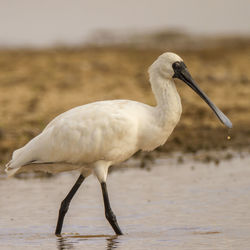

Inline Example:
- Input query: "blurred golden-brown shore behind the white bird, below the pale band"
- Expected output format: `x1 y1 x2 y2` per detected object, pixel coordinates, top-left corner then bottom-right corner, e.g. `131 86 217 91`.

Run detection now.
0 37 250 166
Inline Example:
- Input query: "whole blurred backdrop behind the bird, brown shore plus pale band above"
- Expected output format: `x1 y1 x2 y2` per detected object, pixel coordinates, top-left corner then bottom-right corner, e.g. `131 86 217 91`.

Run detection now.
0 0 250 166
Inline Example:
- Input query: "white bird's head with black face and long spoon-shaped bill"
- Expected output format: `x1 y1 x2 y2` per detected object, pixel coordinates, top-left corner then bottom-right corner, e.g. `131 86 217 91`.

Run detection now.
149 52 232 128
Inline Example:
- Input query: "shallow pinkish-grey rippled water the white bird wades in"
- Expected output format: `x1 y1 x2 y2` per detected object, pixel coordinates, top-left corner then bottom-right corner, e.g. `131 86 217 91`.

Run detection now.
0 153 250 250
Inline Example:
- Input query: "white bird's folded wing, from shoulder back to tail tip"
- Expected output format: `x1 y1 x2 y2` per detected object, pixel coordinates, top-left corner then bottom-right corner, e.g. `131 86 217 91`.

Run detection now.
6 101 142 174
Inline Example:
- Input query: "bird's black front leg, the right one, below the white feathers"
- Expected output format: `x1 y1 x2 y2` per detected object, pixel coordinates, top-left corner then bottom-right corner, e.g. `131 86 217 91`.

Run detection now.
101 182 122 235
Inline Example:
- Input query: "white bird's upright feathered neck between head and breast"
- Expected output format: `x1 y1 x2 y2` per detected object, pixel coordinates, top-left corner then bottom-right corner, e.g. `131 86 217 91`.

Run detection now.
150 74 182 126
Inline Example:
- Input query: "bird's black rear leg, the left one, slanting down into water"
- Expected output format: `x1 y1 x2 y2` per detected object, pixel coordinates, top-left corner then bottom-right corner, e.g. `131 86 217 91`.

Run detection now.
55 175 85 235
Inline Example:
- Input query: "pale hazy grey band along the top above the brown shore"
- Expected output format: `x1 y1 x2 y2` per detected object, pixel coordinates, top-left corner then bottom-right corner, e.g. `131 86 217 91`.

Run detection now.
0 0 250 46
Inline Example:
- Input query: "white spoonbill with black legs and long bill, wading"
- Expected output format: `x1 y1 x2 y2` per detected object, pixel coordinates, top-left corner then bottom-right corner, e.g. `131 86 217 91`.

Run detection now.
5 52 232 236
